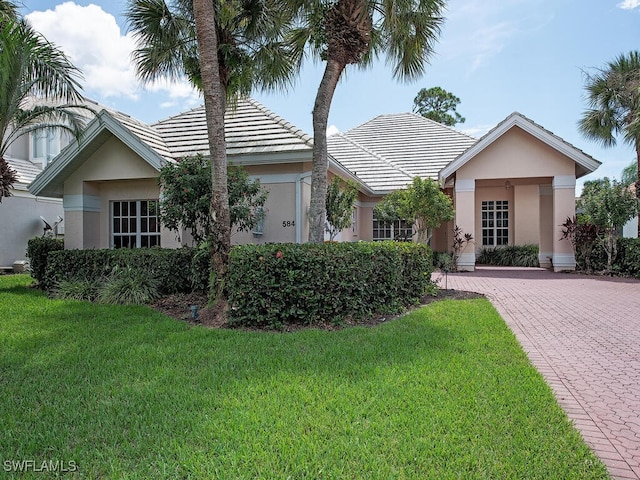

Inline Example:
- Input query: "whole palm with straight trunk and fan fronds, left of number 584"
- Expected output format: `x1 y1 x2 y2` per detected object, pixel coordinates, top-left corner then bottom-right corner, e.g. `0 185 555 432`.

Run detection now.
126 0 300 313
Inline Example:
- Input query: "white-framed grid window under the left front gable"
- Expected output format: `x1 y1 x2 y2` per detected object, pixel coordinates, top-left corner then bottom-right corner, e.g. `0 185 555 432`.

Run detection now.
111 200 160 248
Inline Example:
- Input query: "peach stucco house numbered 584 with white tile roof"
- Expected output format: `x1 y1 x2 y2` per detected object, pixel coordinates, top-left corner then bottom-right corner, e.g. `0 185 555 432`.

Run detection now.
29 99 600 270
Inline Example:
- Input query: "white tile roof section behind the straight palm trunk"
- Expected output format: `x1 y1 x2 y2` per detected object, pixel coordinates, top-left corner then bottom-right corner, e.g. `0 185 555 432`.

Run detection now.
152 98 313 159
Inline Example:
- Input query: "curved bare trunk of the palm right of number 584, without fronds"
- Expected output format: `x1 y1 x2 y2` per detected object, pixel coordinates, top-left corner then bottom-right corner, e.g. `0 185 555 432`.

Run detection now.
309 58 345 243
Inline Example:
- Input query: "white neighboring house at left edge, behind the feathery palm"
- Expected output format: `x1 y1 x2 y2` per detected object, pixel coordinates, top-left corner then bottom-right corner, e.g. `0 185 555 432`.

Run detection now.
0 128 66 270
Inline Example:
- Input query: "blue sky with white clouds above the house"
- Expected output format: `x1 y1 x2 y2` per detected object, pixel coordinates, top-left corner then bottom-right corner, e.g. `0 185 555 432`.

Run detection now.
22 0 640 190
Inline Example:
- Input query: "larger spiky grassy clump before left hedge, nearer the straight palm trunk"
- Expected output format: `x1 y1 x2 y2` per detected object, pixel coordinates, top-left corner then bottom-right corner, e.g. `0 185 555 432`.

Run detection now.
98 267 160 305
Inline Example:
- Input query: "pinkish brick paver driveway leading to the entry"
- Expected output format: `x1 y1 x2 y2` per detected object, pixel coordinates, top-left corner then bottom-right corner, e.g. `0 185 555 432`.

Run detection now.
434 267 640 479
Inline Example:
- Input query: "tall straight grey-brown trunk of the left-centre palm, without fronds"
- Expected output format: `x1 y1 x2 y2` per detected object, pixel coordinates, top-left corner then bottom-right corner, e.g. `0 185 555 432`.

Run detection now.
193 0 231 315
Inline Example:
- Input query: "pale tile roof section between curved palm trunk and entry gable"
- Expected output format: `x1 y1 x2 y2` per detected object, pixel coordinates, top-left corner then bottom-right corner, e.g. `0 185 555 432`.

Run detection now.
328 113 476 190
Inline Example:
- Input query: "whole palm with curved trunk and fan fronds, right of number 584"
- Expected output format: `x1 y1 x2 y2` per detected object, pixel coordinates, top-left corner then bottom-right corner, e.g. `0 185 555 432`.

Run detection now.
292 0 445 243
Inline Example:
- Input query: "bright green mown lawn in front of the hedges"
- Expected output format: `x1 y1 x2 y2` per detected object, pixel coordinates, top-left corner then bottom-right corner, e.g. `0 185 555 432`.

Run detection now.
0 276 608 479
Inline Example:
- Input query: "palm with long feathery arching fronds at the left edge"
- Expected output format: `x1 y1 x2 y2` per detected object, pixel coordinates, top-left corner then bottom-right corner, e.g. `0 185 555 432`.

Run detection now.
0 10 86 201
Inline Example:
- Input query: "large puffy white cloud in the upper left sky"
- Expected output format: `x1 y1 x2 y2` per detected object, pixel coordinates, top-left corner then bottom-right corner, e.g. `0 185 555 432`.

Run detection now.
27 1 200 106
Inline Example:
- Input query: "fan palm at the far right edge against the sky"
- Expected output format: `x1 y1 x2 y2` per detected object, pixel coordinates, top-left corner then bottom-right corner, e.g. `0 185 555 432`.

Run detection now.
578 51 640 237
